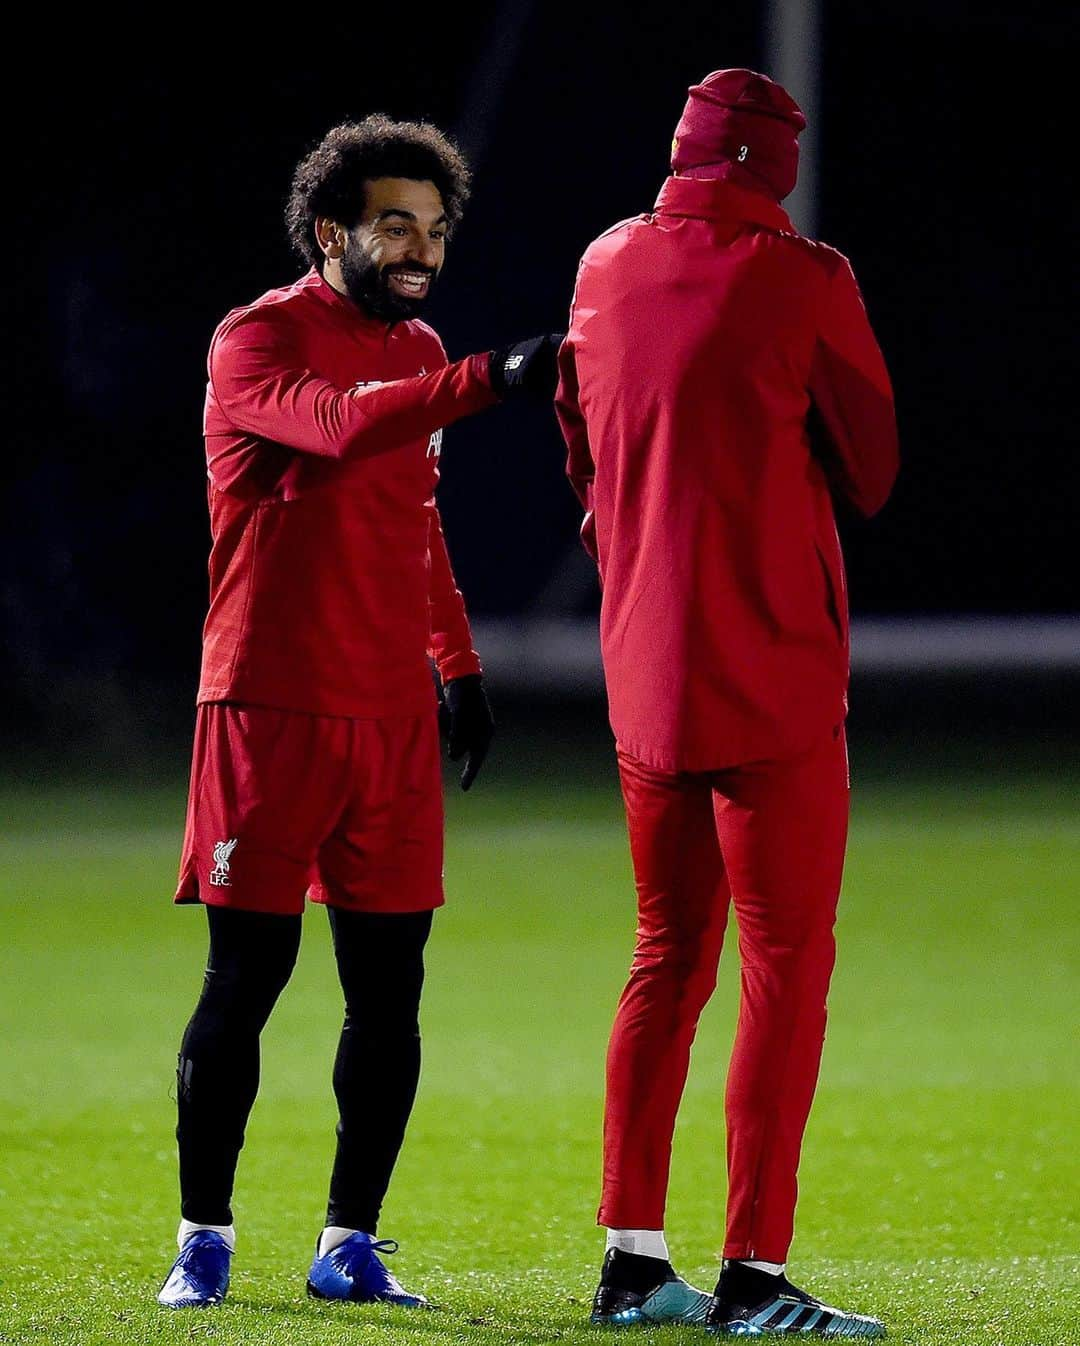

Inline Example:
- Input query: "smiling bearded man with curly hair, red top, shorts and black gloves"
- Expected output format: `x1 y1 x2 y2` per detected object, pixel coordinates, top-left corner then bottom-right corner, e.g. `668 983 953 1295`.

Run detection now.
158 116 558 1308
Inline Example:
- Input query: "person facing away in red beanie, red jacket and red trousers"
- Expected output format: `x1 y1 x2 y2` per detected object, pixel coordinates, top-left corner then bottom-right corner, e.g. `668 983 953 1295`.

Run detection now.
556 70 897 1337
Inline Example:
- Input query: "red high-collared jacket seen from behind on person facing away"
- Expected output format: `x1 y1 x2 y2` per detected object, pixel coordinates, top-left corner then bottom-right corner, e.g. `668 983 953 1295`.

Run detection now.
558 178 897 771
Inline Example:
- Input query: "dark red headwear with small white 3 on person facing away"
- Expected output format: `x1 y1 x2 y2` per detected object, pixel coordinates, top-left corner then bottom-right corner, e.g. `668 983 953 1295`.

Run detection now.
671 70 807 201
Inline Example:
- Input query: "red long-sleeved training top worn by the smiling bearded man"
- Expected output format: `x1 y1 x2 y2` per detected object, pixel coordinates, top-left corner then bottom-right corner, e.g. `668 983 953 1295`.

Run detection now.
198 269 497 717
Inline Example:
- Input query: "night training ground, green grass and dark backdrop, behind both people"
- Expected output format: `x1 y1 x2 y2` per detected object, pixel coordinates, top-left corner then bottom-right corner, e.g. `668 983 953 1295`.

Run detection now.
0 0 1080 1346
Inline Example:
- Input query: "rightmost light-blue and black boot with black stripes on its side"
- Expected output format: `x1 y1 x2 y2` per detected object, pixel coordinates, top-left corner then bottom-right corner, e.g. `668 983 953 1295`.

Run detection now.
706 1263 885 1341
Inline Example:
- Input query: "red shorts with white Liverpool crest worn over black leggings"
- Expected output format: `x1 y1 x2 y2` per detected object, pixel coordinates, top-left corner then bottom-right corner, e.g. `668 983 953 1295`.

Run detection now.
175 703 443 915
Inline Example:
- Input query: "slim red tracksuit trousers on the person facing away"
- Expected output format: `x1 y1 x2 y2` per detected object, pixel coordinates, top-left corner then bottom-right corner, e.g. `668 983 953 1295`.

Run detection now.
598 730 848 1263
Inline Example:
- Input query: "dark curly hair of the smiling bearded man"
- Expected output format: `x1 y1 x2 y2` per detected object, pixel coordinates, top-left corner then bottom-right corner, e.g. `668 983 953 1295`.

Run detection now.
285 112 470 271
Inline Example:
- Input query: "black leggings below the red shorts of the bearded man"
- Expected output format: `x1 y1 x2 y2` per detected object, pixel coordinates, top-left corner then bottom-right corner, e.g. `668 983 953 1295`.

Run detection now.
176 906 431 1233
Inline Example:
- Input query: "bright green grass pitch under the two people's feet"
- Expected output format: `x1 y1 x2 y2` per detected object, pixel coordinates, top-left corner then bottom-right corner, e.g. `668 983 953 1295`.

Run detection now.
0 763 1080 1346
